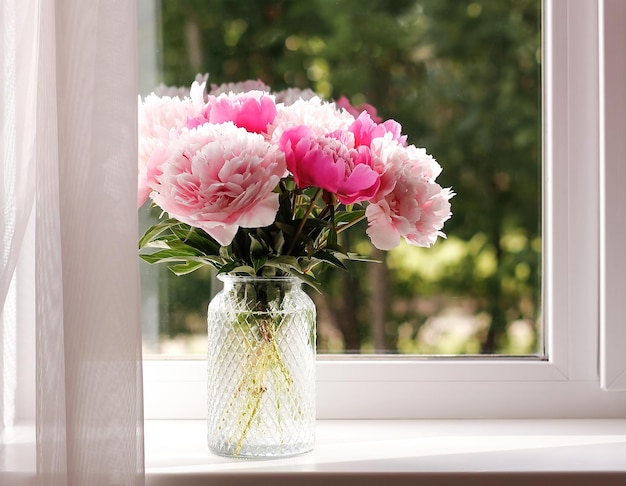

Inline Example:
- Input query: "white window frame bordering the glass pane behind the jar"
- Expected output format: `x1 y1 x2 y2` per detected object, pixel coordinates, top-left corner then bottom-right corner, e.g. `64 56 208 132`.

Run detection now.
144 0 626 419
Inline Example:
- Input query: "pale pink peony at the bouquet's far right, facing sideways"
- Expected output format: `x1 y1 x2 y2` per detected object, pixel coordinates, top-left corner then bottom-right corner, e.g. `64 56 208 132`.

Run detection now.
365 137 454 250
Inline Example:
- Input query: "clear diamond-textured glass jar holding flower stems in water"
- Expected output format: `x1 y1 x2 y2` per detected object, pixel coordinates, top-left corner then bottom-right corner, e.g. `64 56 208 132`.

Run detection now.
208 275 316 458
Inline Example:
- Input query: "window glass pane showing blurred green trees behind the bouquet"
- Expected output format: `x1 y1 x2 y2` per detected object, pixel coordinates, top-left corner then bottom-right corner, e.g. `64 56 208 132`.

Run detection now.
138 0 543 355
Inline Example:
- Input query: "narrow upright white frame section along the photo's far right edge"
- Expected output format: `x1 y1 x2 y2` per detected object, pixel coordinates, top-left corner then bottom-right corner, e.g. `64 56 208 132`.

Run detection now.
600 0 626 390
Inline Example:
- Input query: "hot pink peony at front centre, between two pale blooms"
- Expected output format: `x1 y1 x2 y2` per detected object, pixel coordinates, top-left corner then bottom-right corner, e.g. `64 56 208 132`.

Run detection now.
279 126 380 204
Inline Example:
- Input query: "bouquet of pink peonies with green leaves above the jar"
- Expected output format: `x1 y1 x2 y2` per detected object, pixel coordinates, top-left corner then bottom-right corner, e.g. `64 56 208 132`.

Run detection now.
138 76 454 289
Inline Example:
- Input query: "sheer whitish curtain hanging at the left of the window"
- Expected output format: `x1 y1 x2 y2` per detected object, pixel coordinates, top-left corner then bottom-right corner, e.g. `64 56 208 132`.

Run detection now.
0 0 144 486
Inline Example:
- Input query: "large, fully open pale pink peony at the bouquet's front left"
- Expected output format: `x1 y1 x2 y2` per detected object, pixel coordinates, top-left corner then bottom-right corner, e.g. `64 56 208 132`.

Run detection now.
148 123 285 246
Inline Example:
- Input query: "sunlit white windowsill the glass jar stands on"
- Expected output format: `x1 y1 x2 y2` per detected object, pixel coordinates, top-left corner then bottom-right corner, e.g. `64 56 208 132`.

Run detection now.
145 419 626 486
